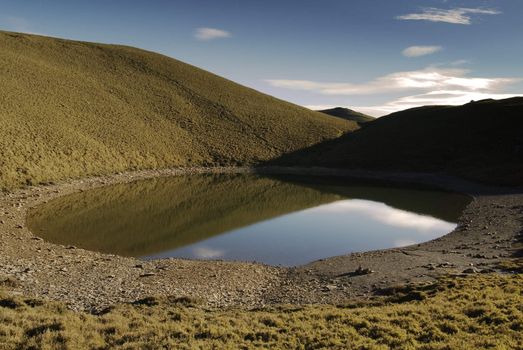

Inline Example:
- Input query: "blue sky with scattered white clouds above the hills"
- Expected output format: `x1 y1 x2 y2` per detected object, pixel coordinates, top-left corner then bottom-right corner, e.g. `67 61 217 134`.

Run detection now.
0 0 523 116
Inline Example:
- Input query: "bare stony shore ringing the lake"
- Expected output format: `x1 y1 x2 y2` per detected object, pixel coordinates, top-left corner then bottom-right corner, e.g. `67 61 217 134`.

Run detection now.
0 168 523 311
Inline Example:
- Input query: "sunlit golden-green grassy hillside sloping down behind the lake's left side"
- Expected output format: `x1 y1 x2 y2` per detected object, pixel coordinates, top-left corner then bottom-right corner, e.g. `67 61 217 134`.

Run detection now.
0 32 356 188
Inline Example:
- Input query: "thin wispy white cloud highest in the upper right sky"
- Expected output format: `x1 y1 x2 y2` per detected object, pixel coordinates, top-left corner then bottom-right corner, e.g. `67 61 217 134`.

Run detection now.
396 7 501 25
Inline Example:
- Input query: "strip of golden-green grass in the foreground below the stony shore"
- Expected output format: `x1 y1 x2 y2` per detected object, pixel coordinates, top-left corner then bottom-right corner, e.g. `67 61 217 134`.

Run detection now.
0 274 523 349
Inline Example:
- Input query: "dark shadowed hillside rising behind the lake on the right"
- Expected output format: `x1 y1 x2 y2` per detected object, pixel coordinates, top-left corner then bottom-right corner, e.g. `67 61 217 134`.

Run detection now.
277 97 523 185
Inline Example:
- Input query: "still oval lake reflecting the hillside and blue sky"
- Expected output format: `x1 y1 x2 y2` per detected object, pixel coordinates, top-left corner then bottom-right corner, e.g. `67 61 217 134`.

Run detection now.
27 174 469 266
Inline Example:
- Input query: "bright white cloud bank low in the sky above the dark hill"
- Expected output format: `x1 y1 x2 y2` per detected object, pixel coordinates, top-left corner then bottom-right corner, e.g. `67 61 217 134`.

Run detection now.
292 67 523 117
